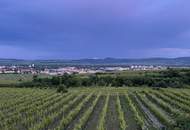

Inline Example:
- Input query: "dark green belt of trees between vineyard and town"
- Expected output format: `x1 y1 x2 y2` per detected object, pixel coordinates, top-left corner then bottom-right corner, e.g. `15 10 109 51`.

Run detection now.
19 68 190 88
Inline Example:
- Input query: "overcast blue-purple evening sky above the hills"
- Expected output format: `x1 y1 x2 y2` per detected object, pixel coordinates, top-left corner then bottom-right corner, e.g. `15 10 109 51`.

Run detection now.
0 0 190 59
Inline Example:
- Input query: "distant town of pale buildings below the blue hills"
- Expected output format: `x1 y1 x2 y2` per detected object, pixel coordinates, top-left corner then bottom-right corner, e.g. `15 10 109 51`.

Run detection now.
0 64 167 75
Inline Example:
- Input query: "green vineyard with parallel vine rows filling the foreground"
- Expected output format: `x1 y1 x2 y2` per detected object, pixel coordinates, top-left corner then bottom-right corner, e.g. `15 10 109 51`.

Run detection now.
0 87 190 130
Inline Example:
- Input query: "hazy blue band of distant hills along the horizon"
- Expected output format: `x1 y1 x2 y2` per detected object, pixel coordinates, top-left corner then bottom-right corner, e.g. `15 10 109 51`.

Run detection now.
0 57 190 66
